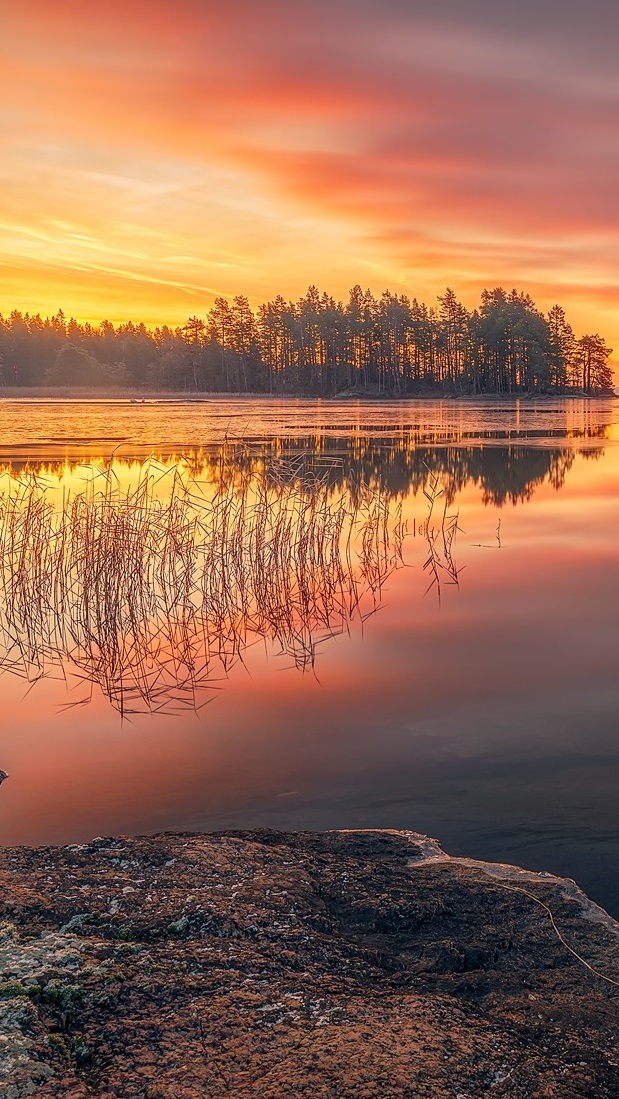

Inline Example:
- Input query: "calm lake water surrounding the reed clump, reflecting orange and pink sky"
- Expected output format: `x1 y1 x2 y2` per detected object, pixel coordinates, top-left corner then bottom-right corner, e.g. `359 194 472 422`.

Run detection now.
0 400 619 914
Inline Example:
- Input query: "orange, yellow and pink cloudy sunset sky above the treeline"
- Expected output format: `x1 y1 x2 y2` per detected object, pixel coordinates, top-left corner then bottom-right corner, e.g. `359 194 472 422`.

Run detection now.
0 0 619 362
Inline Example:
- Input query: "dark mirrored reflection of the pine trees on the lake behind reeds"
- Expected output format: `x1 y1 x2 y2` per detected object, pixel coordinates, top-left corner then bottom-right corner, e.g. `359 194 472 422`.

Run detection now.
0 423 610 507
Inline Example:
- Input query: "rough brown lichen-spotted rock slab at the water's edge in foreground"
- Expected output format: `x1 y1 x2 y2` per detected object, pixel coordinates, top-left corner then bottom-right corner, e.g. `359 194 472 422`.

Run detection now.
0 832 619 1099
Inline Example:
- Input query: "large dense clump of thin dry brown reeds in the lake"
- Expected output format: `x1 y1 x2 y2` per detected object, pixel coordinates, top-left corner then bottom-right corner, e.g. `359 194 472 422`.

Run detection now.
0 456 405 717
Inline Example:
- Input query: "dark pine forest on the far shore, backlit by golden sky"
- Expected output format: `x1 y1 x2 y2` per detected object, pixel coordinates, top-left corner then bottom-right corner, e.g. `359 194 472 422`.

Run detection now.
0 286 612 397
